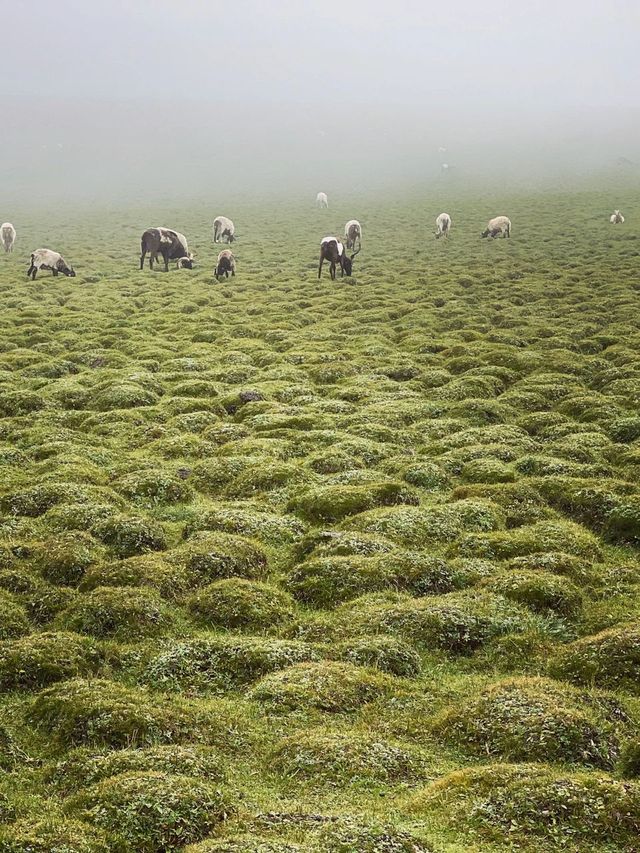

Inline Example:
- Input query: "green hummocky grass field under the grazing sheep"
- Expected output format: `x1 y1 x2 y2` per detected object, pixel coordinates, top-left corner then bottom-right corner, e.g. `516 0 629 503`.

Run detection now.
0 190 640 853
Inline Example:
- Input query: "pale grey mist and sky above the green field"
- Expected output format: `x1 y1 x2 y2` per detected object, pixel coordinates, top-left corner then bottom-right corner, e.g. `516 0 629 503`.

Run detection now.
0 0 640 203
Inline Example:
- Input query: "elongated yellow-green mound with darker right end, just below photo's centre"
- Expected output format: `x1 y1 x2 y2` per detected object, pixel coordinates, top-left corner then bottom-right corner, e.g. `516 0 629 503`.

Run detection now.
289 482 419 524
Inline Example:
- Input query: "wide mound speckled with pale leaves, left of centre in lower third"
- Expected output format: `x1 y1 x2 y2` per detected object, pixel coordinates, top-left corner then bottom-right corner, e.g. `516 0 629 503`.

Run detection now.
142 635 320 693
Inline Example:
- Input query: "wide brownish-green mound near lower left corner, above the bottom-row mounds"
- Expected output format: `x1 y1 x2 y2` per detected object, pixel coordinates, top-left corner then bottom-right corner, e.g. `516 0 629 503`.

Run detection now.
27 678 207 749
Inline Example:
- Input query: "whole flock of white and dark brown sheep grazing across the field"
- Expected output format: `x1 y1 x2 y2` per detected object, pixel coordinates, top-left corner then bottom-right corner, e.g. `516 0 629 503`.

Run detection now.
0 198 624 281
